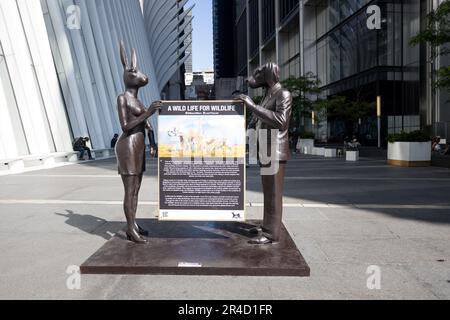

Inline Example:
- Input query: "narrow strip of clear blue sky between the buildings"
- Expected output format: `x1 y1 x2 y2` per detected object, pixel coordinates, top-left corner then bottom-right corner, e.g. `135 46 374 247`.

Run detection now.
188 0 214 71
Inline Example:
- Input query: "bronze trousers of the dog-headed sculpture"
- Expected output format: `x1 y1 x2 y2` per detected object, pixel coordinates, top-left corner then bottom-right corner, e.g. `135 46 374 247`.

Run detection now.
262 162 286 241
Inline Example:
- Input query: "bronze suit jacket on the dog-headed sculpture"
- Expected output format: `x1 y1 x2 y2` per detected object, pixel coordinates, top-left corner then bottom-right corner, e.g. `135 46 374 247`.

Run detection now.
248 84 292 161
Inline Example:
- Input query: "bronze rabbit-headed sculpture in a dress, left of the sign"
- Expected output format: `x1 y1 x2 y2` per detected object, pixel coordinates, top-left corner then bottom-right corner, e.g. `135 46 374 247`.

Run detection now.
115 42 161 244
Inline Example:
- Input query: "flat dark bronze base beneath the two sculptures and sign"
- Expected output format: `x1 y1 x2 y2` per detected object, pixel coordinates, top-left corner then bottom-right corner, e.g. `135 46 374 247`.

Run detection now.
81 220 310 277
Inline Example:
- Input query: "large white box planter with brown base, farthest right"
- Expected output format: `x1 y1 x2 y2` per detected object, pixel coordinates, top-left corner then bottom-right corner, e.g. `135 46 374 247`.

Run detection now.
388 142 431 167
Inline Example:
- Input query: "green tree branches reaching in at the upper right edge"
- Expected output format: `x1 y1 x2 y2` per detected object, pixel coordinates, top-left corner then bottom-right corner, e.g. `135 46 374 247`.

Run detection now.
410 0 450 90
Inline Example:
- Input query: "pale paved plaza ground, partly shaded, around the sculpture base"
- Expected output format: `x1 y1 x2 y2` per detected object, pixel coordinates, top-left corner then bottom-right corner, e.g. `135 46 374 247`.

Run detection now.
0 156 450 300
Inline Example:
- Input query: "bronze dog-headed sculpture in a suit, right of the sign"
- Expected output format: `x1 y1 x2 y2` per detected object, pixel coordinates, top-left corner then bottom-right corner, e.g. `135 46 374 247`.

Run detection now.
236 63 292 244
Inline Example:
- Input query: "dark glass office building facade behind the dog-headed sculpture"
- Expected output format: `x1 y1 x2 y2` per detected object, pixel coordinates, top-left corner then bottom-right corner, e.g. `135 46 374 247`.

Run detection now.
225 0 450 145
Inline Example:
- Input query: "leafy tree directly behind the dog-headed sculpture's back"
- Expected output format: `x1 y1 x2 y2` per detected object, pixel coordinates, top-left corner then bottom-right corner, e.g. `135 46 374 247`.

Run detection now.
282 72 321 127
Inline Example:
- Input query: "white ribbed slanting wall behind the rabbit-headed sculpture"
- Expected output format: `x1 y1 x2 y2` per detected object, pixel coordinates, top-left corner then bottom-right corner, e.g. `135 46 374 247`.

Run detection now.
0 0 162 162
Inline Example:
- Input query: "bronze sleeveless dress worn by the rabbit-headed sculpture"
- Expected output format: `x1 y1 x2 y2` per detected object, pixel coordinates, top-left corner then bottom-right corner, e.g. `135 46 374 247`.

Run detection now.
116 98 146 176
